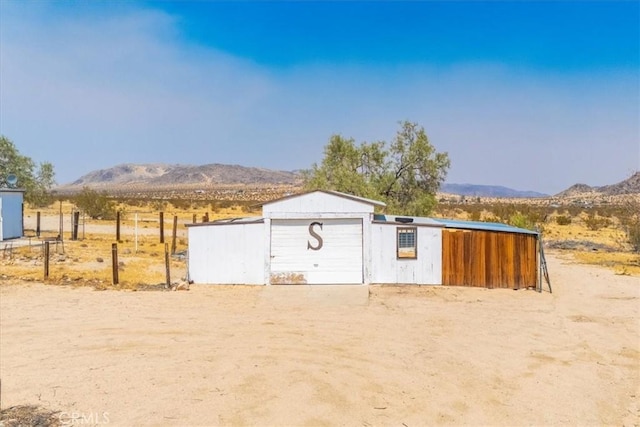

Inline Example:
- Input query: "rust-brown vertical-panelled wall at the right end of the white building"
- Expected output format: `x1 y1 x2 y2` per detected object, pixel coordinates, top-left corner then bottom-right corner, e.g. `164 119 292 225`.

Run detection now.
442 230 538 289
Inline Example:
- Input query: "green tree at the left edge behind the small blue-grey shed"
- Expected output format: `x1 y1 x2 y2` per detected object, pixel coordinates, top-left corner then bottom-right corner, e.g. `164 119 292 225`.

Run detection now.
0 136 55 206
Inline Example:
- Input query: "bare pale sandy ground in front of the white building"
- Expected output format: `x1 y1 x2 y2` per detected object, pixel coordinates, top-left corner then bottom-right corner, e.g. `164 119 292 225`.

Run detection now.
0 254 640 426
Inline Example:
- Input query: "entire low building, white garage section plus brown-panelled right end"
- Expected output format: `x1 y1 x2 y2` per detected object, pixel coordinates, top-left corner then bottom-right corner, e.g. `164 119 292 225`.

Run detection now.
187 190 538 289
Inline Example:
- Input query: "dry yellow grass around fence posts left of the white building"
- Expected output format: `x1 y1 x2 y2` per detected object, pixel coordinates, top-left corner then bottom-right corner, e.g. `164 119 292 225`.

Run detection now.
0 202 258 290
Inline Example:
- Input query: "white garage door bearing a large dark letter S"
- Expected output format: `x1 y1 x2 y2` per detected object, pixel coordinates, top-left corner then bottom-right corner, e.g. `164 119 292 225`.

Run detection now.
270 218 363 284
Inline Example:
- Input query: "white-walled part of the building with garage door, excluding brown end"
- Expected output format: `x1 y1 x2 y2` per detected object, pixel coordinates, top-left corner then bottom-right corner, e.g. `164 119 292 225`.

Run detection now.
187 190 443 285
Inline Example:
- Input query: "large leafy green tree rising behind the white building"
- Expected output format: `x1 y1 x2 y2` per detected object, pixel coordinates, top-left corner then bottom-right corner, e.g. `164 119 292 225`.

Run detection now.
303 121 451 215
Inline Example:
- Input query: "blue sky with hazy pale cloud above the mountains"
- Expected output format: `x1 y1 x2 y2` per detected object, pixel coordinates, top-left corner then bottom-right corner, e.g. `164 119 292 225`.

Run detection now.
0 0 640 194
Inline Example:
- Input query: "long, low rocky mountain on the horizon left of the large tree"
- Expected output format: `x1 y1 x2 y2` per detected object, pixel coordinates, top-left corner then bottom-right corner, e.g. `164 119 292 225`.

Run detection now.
58 163 300 190
